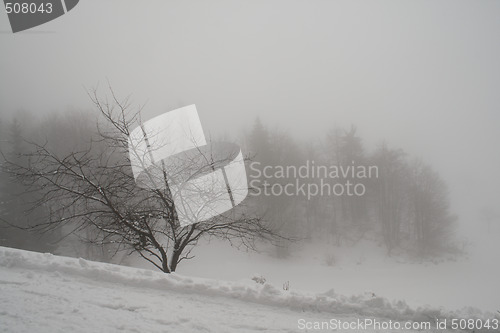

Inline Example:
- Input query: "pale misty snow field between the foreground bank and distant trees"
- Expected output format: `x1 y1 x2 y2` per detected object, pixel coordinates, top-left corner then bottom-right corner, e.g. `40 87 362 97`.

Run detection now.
171 232 500 312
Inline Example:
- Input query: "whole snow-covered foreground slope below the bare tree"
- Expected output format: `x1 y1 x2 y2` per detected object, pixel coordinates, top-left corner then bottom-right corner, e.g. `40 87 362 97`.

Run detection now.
0 248 498 332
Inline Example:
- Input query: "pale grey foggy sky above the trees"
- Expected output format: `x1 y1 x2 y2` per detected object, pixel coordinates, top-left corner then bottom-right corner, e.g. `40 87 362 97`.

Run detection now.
0 0 500 233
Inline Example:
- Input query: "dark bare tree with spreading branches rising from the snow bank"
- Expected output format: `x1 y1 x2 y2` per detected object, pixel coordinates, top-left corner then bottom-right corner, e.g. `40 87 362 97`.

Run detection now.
0 88 281 273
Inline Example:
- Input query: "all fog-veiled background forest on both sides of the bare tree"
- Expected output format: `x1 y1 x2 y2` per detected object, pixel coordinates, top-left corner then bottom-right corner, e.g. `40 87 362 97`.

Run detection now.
0 100 464 268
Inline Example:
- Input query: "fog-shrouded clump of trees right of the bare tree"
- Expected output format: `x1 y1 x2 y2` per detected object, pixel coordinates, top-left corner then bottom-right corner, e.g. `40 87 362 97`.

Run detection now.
243 119 456 257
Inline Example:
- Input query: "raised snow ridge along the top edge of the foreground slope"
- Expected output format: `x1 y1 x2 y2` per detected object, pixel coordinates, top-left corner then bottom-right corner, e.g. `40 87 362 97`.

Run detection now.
0 247 492 322
